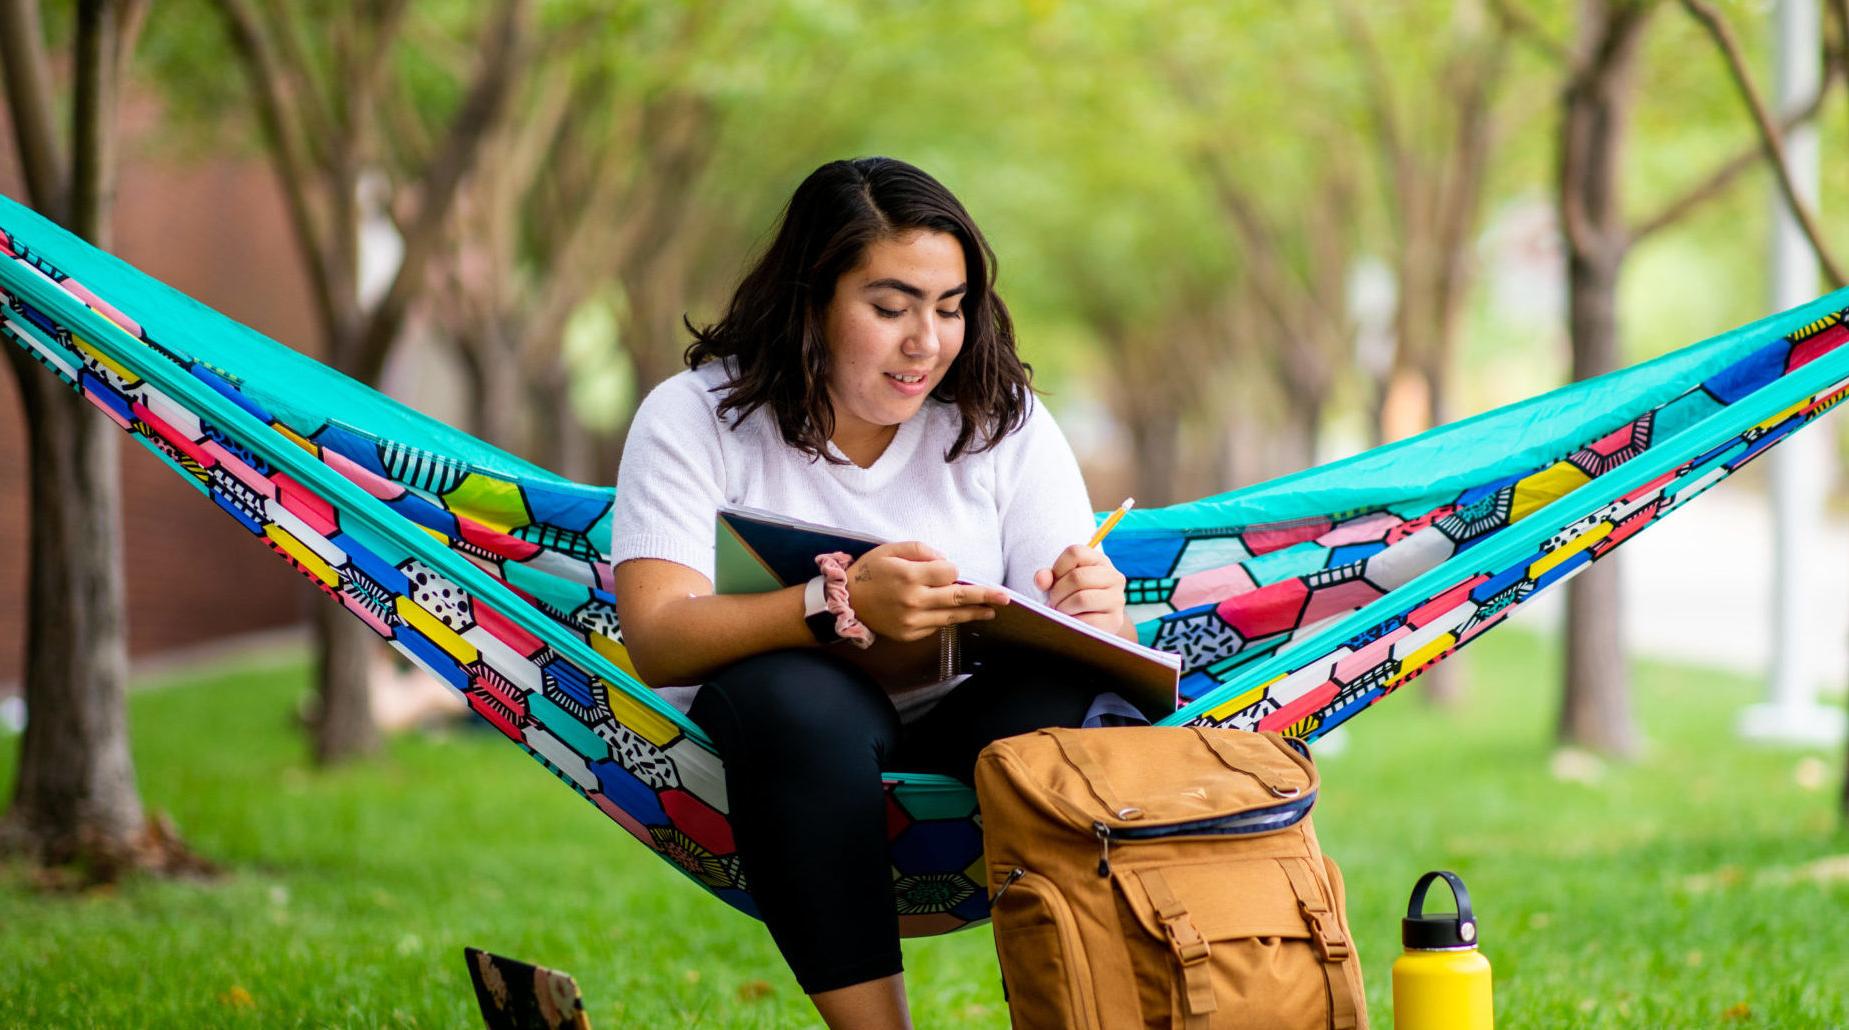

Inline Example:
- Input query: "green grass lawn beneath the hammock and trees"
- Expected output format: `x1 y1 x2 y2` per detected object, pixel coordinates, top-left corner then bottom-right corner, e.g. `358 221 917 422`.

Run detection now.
0 631 1849 1028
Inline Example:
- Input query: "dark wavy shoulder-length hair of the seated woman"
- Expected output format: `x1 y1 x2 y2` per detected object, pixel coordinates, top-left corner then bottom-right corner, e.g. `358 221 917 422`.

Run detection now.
682 157 1034 464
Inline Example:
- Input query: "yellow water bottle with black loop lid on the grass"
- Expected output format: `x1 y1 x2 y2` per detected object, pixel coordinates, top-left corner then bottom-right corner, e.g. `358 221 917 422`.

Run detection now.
1392 873 1496 1030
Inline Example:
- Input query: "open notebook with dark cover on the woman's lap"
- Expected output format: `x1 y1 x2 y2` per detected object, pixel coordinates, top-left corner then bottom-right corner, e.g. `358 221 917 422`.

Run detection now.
714 507 1182 719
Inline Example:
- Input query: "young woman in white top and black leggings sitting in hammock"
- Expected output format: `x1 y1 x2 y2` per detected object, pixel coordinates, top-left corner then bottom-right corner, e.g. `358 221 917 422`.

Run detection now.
612 157 1135 1026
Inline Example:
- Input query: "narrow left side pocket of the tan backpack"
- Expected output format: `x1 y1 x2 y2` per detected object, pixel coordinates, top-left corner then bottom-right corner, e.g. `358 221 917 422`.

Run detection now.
989 867 1098 1030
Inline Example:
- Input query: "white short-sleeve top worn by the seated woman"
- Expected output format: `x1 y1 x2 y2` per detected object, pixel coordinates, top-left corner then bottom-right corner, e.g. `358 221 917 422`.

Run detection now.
610 361 1096 719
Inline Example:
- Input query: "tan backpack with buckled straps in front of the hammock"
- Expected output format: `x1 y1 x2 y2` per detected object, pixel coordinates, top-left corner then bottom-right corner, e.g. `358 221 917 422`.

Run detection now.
976 727 1366 1030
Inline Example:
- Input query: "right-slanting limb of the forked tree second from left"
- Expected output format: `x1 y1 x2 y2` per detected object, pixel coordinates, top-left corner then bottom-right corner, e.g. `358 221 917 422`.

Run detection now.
348 0 531 383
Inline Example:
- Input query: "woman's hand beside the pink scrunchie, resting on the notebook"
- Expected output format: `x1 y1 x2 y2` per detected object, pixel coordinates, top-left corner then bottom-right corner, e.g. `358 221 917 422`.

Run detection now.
847 540 1008 642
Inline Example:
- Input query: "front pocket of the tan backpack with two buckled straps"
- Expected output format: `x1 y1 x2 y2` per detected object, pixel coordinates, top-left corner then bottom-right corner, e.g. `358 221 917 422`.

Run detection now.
1111 856 1359 1030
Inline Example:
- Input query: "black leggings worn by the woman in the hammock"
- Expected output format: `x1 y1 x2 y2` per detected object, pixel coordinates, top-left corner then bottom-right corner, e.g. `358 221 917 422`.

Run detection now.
690 649 1108 995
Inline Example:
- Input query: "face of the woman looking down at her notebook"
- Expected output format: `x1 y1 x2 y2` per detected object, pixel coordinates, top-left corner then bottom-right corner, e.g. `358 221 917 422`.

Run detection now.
823 229 969 440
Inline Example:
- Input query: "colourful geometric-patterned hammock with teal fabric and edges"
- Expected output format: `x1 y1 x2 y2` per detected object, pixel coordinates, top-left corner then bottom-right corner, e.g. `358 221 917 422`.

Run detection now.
0 190 1849 936
